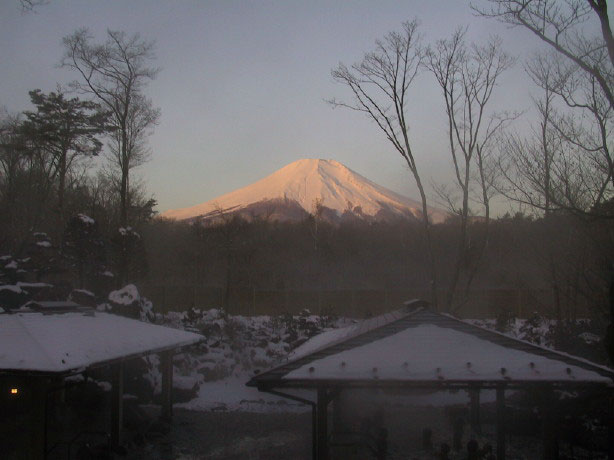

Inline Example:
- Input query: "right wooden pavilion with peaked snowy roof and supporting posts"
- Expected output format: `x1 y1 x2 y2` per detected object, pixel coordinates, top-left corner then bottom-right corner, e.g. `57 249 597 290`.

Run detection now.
247 301 614 460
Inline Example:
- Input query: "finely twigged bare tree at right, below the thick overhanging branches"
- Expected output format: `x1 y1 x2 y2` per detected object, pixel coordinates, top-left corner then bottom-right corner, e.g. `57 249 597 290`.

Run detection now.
500 49 614 217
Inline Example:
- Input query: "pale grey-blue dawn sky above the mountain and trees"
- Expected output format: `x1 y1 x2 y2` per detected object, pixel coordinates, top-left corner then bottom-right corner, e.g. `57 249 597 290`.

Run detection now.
0 0 592 216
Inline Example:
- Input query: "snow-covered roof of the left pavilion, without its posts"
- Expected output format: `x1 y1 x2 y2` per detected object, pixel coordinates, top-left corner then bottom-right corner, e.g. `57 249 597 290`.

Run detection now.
0 310 202 374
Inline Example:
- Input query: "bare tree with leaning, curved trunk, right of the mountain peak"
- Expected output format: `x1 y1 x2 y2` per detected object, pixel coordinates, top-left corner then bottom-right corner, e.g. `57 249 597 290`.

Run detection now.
328 20 437 305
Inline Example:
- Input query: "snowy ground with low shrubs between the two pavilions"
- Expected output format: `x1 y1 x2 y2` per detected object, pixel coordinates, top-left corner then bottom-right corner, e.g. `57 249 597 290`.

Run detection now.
158 309 348 412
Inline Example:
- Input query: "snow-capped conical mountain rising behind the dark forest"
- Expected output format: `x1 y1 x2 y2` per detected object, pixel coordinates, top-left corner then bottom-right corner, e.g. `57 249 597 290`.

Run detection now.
162 159 448 223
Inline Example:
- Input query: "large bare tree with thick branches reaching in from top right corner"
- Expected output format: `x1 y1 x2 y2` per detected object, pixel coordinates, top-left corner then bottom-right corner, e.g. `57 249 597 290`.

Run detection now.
472 0 614 362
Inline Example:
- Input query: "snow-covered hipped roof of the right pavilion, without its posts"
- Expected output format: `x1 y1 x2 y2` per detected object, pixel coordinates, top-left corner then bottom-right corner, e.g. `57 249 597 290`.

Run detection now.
248 303 614 389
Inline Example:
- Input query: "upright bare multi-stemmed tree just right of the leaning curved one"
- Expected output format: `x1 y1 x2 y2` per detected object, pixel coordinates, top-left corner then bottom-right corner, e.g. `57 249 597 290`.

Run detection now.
425 29 514 309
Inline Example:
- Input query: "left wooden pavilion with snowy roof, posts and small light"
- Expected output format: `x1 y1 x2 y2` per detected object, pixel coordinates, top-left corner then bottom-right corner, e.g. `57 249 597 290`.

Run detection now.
0 302 202 459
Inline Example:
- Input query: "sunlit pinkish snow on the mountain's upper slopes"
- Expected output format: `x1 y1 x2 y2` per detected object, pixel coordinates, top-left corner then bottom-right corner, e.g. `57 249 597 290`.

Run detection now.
162 159 448 223
